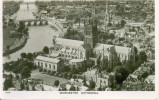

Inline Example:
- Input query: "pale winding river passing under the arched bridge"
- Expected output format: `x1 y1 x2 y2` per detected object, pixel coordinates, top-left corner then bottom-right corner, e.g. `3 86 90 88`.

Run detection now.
3 3 59 63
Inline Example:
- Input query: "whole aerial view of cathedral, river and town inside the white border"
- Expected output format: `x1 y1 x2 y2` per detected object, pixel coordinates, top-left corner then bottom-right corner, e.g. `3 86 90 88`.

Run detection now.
2 0 155 91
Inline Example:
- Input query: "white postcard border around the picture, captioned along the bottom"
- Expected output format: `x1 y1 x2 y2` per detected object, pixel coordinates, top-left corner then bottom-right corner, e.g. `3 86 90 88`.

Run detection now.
0 0 159 100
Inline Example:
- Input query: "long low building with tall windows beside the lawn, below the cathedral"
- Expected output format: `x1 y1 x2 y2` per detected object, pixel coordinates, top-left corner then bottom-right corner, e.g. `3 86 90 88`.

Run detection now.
34 56 64 72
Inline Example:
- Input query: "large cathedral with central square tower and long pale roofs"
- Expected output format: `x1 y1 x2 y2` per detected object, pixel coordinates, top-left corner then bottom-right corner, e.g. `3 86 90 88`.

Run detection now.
50 17 134 67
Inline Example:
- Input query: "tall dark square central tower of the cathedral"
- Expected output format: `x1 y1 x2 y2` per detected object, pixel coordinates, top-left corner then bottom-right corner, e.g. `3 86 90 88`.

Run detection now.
84 18 97 49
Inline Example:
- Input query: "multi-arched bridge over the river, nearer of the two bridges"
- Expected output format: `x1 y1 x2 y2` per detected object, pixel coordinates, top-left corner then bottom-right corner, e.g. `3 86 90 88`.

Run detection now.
17 19 48 26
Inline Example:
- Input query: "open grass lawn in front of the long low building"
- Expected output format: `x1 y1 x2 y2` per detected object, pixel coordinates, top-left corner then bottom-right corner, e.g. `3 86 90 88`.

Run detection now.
30 70 69 86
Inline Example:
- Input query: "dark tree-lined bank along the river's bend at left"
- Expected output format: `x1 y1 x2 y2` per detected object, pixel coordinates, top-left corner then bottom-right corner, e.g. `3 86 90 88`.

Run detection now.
3 35 27 56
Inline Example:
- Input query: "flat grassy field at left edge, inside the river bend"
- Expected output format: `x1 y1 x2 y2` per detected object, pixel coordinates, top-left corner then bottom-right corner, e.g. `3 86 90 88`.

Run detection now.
3 26 16 50
